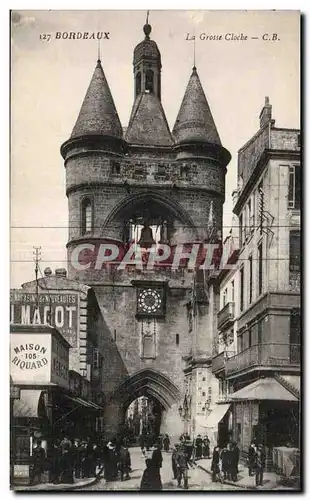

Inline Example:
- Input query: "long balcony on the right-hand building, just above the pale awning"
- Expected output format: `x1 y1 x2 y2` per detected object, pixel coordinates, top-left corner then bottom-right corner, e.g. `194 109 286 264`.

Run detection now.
225 343 300 375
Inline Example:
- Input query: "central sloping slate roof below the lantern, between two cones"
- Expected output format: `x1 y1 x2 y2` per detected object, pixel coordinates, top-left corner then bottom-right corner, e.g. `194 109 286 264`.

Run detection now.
125 92 173 146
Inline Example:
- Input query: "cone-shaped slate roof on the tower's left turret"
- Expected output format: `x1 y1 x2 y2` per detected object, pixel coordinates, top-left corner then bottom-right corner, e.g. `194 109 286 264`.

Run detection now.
71 60 123 139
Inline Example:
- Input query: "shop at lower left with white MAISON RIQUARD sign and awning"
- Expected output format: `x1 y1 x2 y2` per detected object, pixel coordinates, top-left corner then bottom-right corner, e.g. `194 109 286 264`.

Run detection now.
10 325 102 484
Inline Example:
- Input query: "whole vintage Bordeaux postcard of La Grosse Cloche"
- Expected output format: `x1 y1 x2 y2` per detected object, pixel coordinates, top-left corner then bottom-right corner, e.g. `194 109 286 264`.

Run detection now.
9 10 302 492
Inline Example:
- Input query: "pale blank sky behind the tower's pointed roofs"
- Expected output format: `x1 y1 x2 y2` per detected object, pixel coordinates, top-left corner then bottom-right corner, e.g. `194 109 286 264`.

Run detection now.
11 11 300 287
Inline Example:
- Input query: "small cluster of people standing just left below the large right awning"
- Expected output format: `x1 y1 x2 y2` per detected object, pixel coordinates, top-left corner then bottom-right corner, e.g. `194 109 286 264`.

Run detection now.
211 442 240 482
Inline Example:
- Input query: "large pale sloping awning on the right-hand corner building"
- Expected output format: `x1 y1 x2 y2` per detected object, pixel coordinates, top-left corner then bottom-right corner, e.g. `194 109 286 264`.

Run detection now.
229 378 298 401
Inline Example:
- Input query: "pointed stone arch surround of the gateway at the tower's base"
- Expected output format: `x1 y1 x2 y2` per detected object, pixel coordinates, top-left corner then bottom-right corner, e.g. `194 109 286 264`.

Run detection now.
105 368 184 440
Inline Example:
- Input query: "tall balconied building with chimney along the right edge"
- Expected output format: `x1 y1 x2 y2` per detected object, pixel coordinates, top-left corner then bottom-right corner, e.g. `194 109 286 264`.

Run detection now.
213 98 301 459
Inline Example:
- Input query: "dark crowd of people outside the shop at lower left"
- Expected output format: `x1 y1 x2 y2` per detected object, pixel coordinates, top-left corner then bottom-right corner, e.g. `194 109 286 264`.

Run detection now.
30 436 102 485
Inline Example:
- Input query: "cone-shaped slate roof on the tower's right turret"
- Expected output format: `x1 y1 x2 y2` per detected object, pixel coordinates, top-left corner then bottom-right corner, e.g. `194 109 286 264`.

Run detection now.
172 67 221 145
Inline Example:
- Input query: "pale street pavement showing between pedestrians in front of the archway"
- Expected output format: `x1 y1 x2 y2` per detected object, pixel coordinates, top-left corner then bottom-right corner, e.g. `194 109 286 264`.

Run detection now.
83 448 241 491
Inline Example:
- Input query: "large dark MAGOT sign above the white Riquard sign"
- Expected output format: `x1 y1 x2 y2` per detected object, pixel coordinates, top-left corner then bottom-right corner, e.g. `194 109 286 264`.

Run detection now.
10 290 79 347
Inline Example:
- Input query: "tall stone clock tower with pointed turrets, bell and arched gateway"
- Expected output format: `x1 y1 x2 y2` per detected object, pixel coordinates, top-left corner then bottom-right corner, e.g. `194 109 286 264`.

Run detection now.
61 19 230 435
